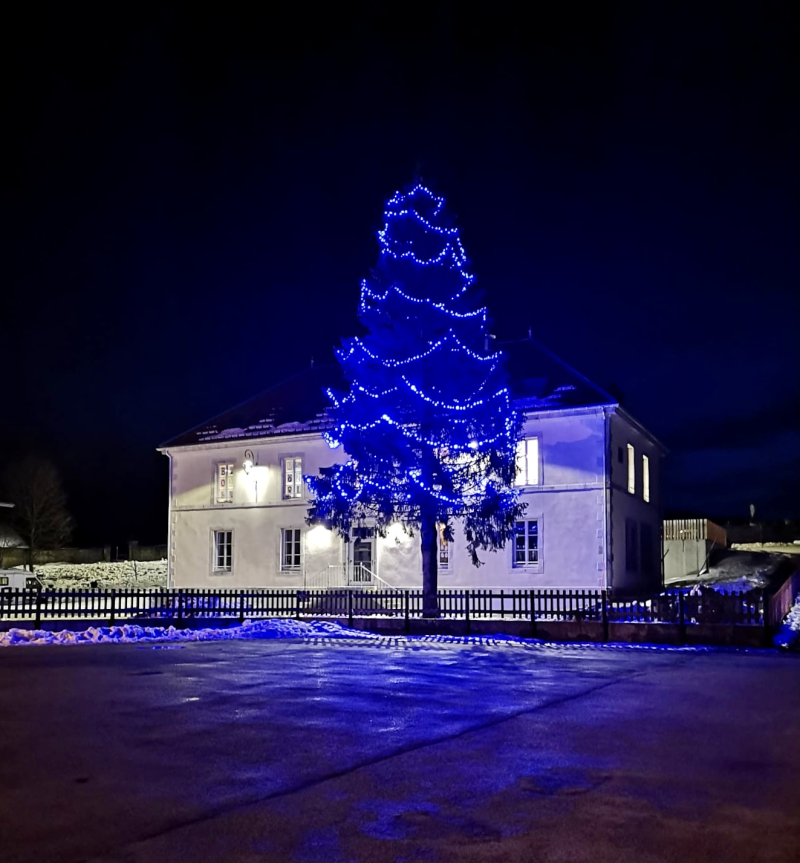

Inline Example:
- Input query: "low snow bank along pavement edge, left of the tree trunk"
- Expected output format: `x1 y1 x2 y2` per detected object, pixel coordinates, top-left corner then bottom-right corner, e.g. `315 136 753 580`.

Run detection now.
0 619 380 647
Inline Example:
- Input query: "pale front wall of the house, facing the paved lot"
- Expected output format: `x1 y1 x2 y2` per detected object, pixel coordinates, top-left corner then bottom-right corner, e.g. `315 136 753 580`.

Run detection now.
161 409 606 588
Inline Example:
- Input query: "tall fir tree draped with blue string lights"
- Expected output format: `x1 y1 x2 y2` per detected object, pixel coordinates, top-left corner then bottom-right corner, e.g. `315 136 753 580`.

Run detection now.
306 184 524 616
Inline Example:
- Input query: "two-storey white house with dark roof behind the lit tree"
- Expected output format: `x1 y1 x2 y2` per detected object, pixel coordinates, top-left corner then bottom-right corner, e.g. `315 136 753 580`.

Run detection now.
159 340 664 591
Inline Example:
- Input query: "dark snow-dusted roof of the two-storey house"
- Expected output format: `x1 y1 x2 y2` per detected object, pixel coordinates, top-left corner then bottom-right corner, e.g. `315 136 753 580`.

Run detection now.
162 339 616 447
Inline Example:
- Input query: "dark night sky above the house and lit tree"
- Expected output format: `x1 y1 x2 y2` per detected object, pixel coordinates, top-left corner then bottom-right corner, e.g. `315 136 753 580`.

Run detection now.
0 2 800 543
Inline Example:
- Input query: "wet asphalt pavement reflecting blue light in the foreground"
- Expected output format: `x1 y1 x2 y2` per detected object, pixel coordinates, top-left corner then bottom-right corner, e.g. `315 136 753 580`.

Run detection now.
0 638 800 863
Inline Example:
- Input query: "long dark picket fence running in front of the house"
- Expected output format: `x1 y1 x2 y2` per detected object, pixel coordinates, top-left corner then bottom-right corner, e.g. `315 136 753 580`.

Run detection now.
0 588 765 627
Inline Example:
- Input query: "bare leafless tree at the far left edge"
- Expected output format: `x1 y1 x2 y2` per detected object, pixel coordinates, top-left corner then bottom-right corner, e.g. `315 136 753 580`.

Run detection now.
5 455 73 572
